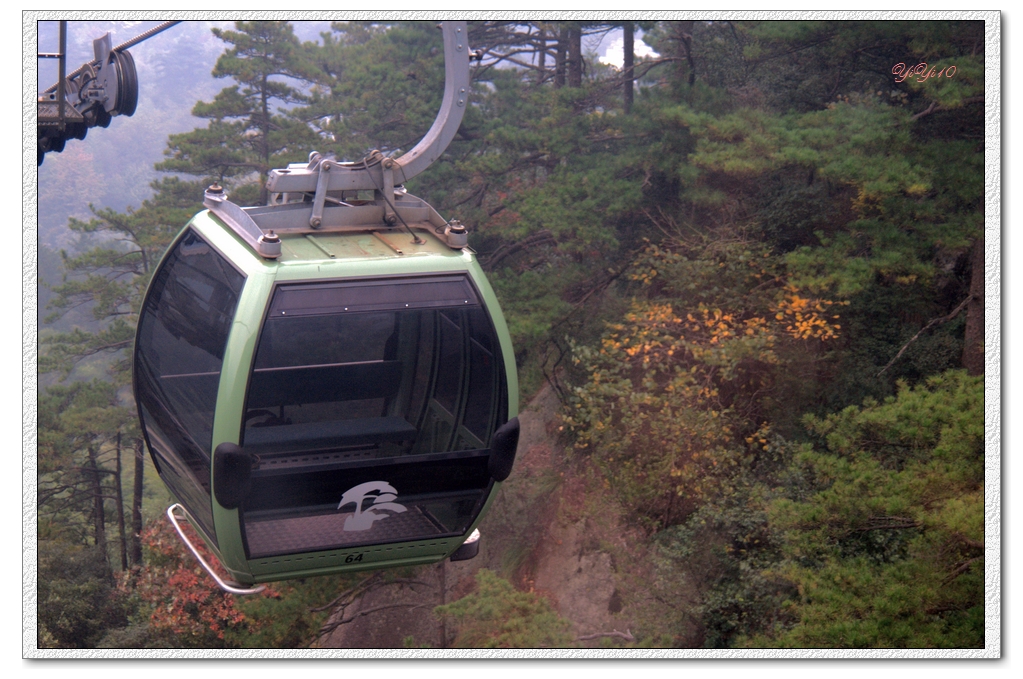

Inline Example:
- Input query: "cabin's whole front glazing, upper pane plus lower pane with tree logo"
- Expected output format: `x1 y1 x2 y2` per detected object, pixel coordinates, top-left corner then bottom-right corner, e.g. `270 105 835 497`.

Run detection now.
236 276 506 557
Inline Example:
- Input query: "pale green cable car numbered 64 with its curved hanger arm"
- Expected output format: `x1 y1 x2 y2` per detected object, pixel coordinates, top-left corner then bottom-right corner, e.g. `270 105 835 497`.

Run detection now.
133 21 519 593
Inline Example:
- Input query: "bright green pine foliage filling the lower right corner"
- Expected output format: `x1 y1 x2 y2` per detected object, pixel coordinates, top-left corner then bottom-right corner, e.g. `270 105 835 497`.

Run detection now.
747 371 984 648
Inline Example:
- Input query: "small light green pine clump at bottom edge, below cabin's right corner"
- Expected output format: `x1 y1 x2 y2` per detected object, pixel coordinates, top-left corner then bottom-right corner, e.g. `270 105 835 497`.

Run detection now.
434 569 573 648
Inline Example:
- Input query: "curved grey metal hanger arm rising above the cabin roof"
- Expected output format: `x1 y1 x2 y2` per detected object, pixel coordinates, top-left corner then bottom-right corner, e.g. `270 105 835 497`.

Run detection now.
395 21 470 181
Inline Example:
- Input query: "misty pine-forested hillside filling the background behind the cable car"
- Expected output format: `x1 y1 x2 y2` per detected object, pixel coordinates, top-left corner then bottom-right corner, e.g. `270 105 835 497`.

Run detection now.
36 20 990 648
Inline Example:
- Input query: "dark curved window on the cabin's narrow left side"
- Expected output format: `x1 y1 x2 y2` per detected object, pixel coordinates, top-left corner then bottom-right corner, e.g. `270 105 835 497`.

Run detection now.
135 229 244 536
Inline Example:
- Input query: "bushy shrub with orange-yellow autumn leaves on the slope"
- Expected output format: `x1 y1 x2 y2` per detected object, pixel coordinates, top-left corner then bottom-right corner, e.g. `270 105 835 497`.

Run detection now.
565 238 841 528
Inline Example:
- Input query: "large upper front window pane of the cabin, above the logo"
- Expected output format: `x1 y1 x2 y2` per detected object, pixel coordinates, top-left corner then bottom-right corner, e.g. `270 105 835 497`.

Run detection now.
242 277 503 458
